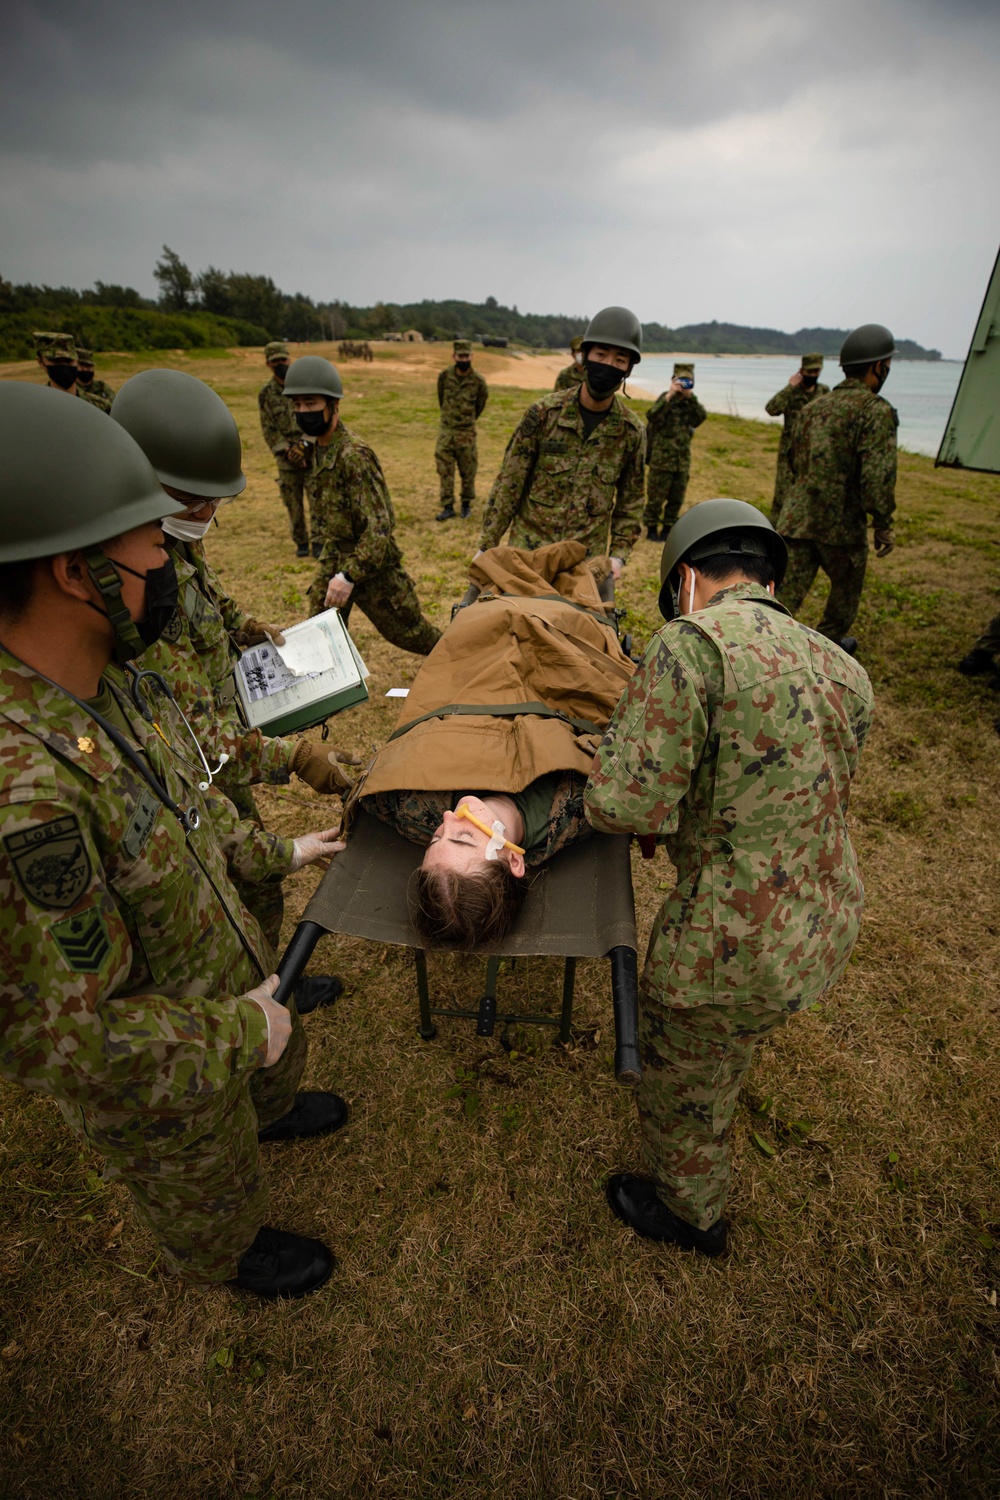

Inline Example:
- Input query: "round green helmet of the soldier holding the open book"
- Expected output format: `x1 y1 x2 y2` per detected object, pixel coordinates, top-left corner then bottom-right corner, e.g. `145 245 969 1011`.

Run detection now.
111 371 246 500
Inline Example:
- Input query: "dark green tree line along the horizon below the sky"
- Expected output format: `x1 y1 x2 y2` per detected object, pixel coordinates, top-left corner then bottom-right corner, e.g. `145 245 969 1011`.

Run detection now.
0 245 942 360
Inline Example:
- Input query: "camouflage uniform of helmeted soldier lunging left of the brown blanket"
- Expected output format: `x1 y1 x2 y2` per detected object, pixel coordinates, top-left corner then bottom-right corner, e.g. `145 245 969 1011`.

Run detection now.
306 422 441 656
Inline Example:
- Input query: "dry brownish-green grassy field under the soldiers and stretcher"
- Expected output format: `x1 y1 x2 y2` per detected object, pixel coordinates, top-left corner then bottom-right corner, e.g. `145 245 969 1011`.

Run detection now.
0 348 1000 1500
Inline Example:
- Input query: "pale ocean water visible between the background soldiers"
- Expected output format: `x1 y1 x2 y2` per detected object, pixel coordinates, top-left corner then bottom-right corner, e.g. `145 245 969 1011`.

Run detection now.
628 354 963 458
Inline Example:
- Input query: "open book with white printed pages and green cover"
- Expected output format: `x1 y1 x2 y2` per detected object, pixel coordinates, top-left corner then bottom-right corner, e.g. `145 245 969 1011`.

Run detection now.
232 609 370 735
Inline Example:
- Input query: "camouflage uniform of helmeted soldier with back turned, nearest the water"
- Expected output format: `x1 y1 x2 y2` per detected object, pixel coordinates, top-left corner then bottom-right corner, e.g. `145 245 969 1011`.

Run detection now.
780 380 900 641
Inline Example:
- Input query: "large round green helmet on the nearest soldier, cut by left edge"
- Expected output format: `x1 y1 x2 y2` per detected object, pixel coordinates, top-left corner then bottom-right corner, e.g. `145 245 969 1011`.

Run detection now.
0 381 184 563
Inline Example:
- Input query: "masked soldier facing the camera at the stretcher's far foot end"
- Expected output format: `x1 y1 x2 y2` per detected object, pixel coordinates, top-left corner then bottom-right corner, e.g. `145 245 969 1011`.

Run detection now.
480 308 645 579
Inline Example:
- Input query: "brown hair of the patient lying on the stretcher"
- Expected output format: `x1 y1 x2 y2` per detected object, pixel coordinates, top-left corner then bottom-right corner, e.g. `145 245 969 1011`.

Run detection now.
411 860 528 953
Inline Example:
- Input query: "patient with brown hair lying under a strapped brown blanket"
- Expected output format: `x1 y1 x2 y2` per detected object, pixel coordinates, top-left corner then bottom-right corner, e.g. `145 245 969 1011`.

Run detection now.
345 542 633 950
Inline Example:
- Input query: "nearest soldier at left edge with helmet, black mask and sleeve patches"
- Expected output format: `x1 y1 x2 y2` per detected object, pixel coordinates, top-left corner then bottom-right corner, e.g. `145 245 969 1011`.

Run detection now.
0 383 346 1296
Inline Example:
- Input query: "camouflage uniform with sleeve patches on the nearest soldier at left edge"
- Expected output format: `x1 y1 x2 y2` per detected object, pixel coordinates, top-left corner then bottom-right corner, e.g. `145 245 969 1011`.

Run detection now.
0 650 306 1283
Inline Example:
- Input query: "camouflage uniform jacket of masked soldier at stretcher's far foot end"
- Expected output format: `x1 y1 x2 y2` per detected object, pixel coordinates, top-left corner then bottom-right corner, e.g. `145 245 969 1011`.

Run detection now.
480 390 645 561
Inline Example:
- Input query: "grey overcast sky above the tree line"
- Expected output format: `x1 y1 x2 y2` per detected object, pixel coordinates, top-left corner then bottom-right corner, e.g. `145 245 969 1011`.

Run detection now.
0 0 1000 357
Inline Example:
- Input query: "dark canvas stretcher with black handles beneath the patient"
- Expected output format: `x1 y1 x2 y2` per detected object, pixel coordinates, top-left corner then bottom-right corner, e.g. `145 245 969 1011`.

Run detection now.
274 812 640 1083
